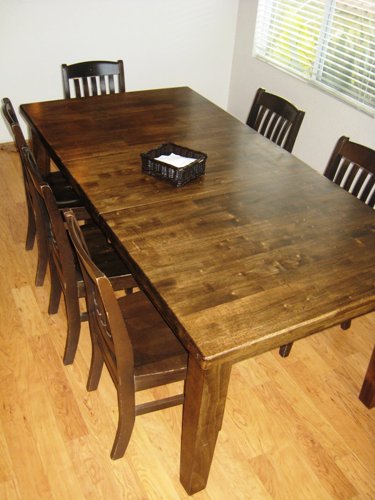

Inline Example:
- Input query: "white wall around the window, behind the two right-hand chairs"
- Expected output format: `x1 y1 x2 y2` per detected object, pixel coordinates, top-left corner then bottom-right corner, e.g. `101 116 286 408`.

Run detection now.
228 0 375 172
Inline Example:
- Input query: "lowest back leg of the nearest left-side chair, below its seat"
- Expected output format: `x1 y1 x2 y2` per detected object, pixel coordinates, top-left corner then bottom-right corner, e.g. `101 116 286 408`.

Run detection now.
111 387 135 460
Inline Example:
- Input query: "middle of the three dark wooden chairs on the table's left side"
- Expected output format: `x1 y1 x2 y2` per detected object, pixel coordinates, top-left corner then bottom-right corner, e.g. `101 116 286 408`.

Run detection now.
23 148 137 365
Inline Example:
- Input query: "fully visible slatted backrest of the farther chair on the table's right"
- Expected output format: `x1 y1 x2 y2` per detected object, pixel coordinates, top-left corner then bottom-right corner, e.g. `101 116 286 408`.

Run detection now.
246 88 305 153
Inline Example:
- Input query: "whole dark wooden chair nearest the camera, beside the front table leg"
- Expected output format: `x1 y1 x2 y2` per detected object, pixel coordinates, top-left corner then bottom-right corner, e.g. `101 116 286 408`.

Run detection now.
64 210 187 459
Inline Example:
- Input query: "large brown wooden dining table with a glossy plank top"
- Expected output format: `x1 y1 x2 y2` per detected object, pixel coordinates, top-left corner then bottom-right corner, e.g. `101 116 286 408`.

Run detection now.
21 87 375 494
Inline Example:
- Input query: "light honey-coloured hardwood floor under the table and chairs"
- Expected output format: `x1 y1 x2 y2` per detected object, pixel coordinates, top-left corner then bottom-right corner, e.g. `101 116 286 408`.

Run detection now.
0 145 375 500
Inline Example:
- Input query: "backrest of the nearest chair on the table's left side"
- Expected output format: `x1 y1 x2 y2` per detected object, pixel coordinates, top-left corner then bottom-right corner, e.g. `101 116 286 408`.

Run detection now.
64 210 135 388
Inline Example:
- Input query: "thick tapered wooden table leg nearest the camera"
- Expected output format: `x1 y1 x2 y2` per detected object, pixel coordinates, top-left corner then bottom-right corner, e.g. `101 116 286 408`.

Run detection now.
180 356 231 495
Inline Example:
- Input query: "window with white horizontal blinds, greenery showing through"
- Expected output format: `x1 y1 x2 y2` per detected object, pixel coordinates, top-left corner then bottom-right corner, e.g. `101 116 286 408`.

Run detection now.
254 0 375 115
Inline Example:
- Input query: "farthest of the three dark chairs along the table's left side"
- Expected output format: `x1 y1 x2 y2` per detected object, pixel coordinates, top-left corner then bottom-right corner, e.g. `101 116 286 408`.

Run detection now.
2 97 82 286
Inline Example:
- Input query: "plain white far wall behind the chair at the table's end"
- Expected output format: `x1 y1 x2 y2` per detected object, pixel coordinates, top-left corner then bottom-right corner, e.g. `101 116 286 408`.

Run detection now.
0 0 238 142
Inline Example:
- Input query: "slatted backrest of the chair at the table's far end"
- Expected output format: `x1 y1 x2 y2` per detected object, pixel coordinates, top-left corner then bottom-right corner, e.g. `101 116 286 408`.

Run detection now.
61 60 125 99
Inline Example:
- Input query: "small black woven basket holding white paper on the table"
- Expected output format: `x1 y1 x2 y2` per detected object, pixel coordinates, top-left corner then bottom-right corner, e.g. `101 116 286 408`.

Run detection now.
141 143 207 187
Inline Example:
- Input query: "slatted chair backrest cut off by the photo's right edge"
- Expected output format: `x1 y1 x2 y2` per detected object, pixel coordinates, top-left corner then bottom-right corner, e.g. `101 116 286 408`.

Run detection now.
324 136 375 208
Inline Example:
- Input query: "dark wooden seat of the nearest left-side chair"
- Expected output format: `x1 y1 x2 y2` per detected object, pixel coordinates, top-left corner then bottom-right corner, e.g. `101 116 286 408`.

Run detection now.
118 292 187 390
